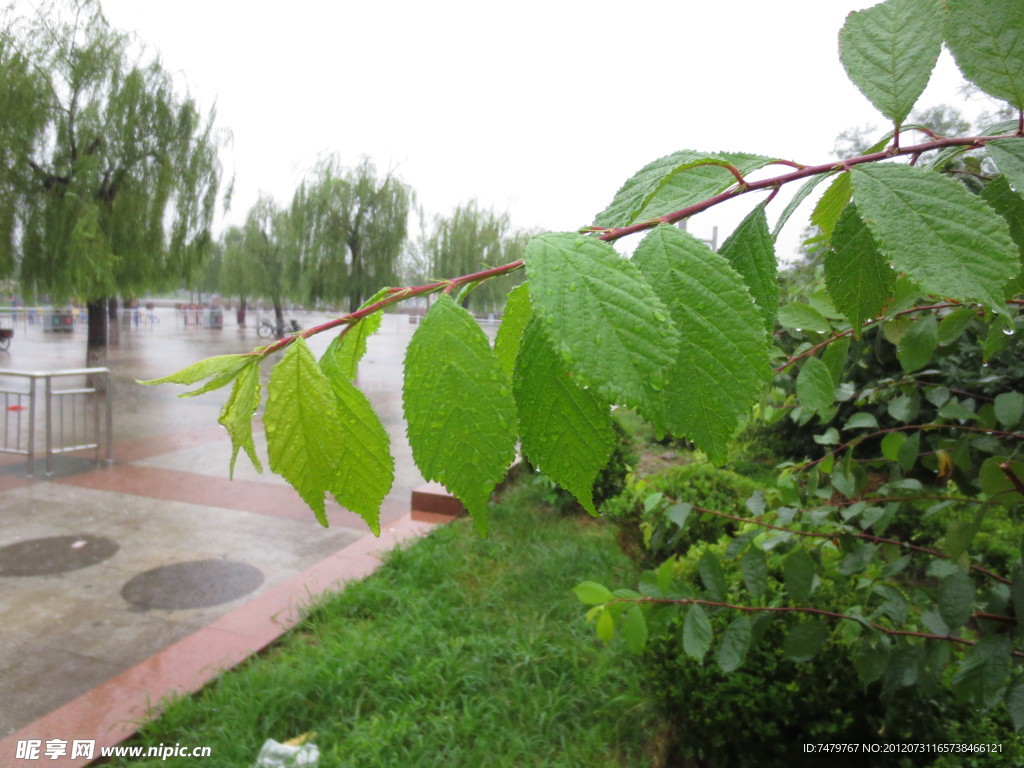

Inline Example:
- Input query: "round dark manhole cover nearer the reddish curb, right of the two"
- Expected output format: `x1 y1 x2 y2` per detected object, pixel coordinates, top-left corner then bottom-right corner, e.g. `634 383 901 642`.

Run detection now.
121 560 263 610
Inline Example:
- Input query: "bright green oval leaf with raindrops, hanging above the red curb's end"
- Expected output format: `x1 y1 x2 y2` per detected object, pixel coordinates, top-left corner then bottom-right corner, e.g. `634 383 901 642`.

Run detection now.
402 296 516 532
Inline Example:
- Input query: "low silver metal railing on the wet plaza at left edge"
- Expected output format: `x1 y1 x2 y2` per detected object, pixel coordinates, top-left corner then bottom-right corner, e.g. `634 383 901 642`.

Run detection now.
0 368 114 477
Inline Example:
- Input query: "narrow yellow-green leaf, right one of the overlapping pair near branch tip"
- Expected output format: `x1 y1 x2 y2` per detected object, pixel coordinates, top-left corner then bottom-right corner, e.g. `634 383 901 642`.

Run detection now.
321 354 394 536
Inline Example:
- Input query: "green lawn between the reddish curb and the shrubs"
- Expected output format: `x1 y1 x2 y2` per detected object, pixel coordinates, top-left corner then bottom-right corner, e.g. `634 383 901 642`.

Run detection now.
111 488 656 768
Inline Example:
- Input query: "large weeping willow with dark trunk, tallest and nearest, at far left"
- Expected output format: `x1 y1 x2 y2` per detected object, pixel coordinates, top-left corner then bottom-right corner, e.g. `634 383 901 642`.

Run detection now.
0 0 221 364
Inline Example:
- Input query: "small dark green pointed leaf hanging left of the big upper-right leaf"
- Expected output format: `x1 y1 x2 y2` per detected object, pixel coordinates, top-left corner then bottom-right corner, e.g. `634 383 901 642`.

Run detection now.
824 201 896 337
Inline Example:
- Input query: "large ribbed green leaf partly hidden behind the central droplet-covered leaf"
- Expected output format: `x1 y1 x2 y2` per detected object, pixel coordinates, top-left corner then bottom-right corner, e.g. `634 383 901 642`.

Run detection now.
633 226 771 464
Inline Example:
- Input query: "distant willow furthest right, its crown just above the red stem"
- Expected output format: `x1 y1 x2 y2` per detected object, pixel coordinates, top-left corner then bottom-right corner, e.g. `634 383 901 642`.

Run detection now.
423 200 531 310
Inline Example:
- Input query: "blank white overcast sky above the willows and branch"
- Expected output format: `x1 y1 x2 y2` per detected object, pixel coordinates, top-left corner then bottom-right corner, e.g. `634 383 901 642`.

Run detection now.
96 0 983 256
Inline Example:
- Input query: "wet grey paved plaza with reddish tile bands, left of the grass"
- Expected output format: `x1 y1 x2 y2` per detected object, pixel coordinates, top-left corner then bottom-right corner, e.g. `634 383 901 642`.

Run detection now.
0 309 430 766
